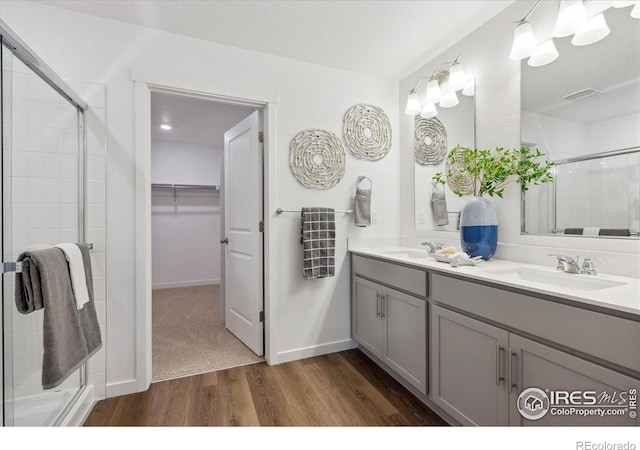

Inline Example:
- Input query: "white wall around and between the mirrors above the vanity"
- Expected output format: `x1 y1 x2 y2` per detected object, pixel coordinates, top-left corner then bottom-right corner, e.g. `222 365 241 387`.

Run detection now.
398 1 640 277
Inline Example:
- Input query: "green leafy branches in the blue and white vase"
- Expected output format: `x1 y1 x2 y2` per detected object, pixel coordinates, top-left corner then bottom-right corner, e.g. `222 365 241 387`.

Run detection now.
432 145 553 198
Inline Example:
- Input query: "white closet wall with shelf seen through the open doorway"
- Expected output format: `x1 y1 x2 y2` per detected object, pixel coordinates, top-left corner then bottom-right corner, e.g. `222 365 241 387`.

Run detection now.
151 141 223 289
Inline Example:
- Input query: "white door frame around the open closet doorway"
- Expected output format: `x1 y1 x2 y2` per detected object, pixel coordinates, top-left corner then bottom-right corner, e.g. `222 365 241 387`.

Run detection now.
132 68 278 392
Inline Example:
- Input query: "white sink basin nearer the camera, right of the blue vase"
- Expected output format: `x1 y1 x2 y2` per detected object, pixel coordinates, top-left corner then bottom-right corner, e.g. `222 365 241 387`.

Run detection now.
492 268 624 291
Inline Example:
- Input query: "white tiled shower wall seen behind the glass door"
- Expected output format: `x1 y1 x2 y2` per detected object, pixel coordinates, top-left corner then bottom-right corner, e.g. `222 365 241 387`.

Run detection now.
5 58 84 408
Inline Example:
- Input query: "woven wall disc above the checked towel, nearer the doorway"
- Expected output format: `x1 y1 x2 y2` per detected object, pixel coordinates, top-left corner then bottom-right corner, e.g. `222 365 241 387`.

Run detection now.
289 129 346 189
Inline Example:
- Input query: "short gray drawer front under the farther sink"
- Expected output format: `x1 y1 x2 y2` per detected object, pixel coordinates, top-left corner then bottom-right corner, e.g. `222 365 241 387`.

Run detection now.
351 255 427 297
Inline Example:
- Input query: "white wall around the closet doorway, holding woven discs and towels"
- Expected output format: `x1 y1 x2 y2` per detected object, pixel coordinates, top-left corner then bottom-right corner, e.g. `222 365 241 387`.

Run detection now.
1 1 400 394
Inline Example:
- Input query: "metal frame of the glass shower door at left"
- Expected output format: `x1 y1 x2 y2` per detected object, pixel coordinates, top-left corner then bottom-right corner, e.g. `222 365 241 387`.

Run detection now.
0 19 88 426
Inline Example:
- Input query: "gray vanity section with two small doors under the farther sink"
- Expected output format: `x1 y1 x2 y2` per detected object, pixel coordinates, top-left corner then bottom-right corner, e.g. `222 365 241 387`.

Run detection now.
352 255 427 394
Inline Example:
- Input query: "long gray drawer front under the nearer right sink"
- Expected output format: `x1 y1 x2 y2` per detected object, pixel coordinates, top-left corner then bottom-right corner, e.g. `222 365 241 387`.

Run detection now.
431 274 640 372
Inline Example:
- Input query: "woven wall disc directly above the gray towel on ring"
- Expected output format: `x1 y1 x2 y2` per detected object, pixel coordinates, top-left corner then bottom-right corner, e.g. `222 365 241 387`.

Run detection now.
343 104 391 161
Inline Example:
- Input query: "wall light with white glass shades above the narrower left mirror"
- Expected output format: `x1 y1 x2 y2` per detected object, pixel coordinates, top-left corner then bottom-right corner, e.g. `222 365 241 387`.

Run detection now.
404 55 475 119
